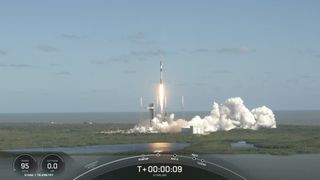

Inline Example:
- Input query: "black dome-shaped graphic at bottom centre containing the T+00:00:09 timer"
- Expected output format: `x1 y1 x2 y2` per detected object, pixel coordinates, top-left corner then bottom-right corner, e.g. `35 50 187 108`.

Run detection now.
74 154 246 180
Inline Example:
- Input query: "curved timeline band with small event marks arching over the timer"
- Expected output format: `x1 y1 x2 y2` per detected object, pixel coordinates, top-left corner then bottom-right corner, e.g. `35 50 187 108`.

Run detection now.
73 154 247 180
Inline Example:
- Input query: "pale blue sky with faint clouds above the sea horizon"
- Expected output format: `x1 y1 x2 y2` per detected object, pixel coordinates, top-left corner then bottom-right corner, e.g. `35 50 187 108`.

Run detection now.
0 0 320 113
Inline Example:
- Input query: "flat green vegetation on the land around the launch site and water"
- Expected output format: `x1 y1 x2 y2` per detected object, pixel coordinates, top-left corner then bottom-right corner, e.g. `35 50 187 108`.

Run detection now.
0 123 320 155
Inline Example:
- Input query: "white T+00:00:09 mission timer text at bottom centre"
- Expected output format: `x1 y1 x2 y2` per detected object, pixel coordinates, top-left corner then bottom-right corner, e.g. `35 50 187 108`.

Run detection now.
137 165 183 173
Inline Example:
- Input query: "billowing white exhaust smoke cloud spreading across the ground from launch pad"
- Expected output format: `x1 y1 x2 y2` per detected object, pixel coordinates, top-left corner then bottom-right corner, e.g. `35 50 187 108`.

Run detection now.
130 97 276 134
